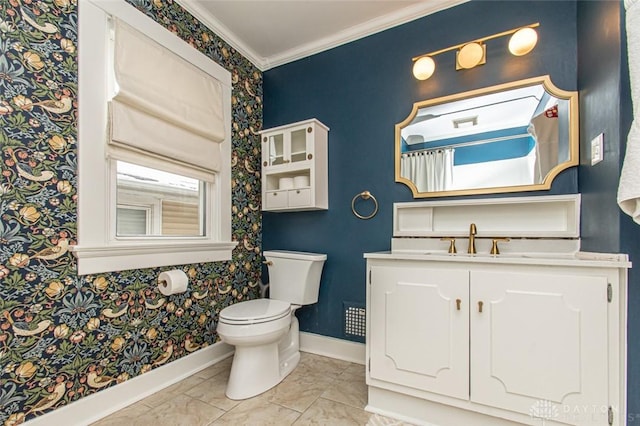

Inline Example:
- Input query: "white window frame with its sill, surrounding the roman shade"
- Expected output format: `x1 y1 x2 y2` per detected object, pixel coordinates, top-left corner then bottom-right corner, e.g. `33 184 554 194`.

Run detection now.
73 0 237 275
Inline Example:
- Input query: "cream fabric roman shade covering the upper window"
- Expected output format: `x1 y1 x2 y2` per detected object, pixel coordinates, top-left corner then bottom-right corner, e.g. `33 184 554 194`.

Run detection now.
108 19 225 181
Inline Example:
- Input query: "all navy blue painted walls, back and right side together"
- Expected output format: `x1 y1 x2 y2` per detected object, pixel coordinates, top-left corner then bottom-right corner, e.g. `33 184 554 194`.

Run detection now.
263 1 640 416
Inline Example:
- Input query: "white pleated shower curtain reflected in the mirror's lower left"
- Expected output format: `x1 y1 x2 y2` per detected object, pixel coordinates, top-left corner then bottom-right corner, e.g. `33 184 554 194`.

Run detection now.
401 148 455 192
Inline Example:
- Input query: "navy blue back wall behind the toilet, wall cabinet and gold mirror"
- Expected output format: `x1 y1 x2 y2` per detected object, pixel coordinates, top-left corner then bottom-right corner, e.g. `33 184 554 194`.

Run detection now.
263 1 578 338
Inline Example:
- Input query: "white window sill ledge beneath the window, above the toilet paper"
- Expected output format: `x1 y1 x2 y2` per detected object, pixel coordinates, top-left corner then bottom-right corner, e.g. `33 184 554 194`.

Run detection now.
72 241 238 275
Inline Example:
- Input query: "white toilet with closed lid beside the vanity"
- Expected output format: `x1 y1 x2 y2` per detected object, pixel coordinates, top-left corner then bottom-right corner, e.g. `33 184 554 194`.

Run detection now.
217 250 327 399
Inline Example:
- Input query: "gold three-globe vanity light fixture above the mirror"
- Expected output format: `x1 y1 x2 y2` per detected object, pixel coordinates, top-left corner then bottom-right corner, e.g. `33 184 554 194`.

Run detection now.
412 22 540 80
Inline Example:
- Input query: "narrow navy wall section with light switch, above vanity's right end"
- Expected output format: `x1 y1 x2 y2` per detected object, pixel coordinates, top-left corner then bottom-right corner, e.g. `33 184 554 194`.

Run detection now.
578 1 621 252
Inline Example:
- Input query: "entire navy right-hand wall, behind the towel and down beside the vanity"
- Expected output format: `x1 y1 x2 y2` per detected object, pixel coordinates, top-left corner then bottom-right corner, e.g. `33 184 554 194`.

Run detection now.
578 1 640 425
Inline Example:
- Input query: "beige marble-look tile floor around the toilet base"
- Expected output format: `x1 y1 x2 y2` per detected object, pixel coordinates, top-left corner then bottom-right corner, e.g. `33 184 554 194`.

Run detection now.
92 352 407 426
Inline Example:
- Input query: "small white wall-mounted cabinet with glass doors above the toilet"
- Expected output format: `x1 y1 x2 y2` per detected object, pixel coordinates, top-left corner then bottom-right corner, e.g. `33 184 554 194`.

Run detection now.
260 119 329 211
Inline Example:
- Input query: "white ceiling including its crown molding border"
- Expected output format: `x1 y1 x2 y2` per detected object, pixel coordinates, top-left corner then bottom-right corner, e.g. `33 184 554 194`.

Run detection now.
176 0 468 71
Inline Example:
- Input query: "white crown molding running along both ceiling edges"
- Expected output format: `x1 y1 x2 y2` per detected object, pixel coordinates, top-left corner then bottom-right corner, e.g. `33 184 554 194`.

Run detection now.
176 0 469 71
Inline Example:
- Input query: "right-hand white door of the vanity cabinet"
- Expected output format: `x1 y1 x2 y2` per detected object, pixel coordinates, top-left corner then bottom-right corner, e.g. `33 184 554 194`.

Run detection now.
470 271 609 425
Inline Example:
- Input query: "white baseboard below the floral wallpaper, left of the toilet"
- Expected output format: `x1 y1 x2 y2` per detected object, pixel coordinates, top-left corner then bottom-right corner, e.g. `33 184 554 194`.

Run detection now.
25 342 233 426
